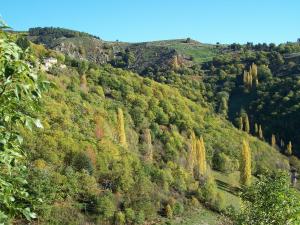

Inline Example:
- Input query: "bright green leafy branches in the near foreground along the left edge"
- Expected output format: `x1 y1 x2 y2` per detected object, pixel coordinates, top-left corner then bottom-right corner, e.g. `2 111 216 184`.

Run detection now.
0 22 43 224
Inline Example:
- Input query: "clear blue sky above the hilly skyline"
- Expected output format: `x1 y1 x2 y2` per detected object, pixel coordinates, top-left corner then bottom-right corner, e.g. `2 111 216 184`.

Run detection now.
0 0 300 43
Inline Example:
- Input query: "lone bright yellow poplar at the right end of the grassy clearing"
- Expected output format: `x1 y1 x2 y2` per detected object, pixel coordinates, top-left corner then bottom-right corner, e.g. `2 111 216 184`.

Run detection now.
240 140 251 186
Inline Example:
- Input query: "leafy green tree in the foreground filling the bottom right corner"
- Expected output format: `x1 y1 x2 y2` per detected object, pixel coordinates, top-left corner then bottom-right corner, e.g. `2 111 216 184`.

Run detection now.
235 171 300 225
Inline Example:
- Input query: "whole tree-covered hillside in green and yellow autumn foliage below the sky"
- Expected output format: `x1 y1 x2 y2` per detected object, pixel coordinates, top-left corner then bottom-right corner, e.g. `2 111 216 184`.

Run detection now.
0 24 300 225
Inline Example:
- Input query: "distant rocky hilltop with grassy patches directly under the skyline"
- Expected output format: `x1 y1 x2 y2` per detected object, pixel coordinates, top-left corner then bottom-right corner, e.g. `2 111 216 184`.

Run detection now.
28 27 220 73
